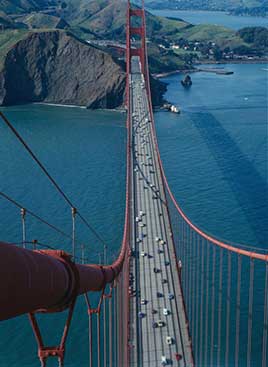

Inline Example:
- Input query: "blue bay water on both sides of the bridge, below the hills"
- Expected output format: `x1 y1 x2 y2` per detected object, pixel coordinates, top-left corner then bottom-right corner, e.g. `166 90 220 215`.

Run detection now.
0 65 267 367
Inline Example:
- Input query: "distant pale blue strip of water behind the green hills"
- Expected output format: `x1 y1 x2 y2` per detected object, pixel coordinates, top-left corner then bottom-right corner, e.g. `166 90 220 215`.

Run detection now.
150 10 268 30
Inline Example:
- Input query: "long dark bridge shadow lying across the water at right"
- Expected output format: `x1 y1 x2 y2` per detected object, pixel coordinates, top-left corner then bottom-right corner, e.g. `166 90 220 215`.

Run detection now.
189 112 268 247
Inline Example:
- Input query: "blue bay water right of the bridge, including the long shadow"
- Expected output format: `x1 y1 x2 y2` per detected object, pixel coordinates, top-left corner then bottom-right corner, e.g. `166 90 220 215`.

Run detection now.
156 64 268 248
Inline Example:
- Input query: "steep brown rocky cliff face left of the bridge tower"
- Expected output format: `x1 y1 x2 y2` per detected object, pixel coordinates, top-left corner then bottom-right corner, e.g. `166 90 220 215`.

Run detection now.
0 31 125 108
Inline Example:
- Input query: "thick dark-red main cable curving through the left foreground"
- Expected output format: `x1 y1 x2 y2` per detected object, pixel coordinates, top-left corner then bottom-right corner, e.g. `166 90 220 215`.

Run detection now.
0 241 128 320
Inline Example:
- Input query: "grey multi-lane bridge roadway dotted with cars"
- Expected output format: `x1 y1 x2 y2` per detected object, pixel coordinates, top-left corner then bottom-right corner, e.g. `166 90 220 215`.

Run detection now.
130 57 192 367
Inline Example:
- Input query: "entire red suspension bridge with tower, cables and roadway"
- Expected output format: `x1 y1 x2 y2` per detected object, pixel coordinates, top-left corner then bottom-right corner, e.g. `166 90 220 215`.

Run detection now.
0 2 268 367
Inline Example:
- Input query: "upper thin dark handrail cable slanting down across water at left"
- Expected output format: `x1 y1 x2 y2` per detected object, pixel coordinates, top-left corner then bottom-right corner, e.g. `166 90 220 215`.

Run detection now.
0 111 106 246
